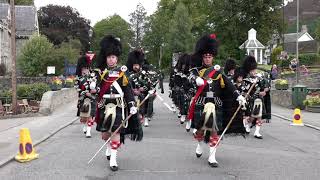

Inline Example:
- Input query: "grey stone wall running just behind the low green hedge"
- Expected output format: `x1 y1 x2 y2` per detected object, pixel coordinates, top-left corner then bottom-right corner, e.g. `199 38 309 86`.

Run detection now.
0 76 50 90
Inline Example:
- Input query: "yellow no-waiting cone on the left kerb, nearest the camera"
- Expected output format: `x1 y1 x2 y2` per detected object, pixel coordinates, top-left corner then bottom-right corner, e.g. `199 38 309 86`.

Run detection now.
15 128 39 162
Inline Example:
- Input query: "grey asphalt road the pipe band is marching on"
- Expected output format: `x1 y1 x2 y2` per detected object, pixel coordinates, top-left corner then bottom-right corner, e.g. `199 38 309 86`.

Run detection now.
0 85 320 180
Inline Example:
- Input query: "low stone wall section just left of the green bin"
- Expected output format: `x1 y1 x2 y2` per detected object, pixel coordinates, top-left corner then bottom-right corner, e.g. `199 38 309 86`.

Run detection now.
270 90 292 108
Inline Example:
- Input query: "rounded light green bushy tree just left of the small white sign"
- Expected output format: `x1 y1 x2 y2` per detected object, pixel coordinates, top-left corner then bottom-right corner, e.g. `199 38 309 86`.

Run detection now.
18 35 54 76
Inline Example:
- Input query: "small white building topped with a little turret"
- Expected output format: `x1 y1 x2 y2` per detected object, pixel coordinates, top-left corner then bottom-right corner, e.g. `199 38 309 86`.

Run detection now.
239 28 266 64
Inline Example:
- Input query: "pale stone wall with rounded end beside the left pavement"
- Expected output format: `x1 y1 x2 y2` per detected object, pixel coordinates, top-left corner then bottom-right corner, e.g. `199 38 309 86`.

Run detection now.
39 88 78 115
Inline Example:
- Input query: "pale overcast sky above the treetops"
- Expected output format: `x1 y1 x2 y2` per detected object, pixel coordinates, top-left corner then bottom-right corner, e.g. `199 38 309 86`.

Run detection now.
34 0 159 26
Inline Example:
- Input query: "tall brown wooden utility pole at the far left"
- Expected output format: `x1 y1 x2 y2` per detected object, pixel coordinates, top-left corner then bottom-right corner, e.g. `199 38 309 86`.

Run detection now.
10 0 17 114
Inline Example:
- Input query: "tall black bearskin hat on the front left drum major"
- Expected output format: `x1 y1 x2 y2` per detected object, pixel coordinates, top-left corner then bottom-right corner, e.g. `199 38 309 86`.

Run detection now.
97 35 122 69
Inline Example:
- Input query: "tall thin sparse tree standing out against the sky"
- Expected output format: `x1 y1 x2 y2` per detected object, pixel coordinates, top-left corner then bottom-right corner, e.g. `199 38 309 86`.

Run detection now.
130 3 147 48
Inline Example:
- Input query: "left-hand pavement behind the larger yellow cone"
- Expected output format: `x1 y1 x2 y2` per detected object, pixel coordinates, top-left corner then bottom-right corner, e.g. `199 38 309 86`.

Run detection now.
0 101 78 167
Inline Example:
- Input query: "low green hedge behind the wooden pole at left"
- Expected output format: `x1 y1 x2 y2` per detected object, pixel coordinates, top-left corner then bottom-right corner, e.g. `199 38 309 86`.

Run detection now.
0 83 50 101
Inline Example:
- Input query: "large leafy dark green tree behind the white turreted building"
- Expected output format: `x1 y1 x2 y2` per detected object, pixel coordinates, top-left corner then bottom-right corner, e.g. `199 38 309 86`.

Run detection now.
209 0 283 59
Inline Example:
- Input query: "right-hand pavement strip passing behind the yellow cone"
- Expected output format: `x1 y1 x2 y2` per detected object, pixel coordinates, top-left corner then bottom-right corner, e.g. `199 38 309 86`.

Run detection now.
271 104 320 130
